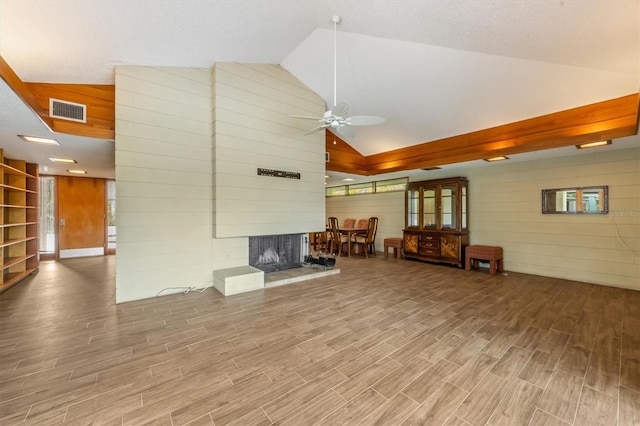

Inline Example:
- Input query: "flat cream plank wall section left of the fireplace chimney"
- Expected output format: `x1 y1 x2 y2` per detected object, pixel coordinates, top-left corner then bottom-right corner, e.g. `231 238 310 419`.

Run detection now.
115 66 212 302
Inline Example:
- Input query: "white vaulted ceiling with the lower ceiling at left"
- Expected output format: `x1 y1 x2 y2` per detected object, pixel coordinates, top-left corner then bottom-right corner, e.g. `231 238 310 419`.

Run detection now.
0 0 640 179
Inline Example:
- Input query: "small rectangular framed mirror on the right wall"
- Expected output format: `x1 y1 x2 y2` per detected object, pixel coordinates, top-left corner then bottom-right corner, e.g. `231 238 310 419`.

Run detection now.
542 186 609 214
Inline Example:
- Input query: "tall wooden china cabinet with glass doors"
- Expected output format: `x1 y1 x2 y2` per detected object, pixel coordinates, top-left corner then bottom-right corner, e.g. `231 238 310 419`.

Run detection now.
404 177 469 268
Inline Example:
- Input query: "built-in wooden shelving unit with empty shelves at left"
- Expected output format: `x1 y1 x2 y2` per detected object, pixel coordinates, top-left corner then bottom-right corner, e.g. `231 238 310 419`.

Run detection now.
0 149 39 292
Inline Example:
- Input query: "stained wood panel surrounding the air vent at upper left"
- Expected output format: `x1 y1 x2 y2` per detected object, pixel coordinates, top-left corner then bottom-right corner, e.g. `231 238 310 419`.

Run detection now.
0 56 115 139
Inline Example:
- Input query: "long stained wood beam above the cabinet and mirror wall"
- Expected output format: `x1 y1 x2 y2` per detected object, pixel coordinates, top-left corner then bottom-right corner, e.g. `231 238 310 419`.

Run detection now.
326 93 640 176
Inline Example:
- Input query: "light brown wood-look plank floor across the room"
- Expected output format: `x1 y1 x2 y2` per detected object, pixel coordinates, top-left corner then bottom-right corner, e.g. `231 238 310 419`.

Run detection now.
0 255 640 426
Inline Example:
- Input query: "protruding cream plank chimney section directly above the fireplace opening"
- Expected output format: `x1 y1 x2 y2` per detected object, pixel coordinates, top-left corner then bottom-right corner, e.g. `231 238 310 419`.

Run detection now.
214 63 325 238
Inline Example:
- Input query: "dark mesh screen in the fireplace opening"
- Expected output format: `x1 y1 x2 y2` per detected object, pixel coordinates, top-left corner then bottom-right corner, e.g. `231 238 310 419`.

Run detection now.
249 234 304 272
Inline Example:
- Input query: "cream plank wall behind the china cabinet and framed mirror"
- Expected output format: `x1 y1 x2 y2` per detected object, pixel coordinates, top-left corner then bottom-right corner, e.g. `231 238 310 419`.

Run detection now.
327 148 640 290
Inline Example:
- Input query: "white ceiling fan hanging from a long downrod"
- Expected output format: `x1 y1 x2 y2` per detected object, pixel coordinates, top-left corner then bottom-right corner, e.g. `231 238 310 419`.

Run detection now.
291 15 385 137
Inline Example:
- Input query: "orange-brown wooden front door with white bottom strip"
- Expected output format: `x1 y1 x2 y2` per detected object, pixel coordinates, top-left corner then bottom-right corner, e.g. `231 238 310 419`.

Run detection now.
58 176 106 257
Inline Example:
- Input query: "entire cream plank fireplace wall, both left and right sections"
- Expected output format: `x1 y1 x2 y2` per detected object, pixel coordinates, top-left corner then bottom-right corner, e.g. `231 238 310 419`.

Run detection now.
115 64 324 303
